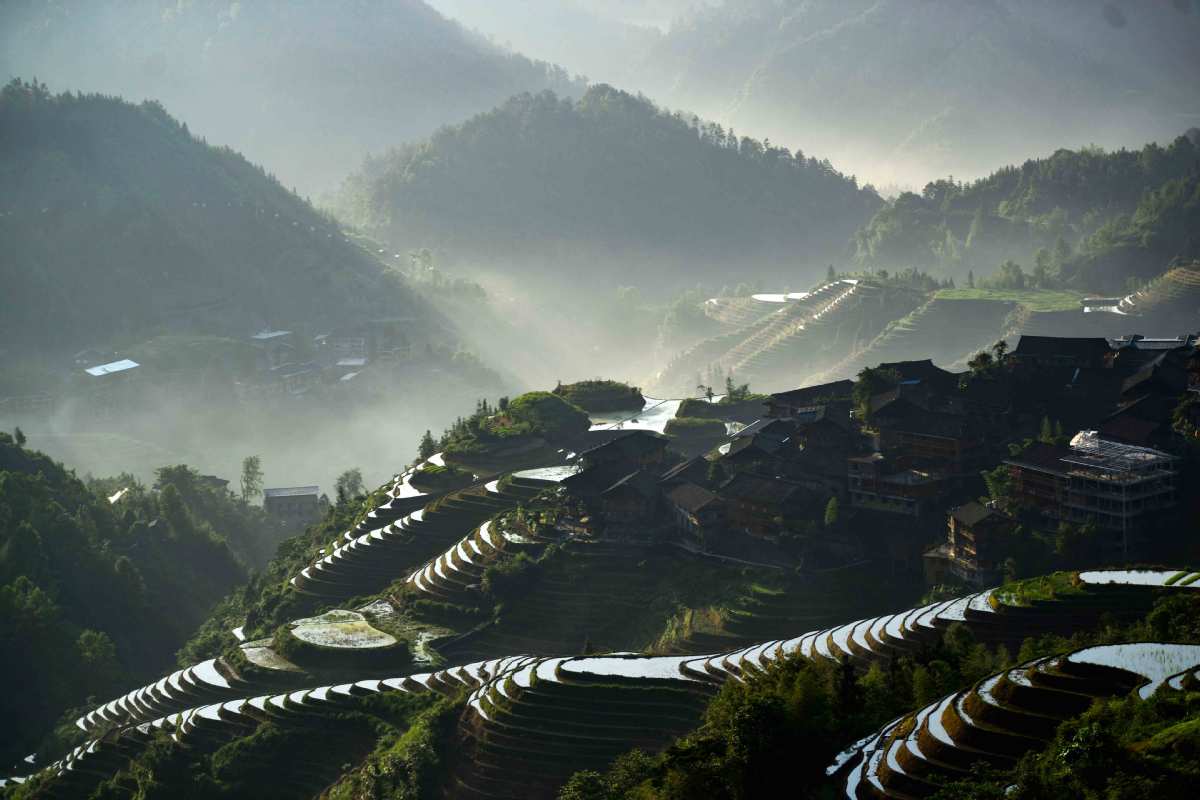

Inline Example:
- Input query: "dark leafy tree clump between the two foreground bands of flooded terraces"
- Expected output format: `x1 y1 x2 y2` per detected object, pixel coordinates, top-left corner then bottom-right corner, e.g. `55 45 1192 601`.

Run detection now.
558 626 1012 800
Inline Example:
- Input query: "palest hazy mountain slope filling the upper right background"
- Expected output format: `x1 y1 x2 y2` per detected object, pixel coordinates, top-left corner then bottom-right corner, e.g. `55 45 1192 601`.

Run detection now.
628 0 1200 185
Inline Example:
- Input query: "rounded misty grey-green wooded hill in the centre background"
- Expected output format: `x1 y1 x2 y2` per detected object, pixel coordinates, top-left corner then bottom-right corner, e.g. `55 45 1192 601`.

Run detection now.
338 85 881 285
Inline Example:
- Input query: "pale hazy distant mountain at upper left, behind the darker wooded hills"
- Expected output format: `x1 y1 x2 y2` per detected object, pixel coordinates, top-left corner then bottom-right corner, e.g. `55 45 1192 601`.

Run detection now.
0 0 576 193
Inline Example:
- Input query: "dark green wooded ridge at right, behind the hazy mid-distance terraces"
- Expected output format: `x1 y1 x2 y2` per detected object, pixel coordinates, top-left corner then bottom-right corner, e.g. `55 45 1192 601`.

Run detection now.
854 131 1200 291
